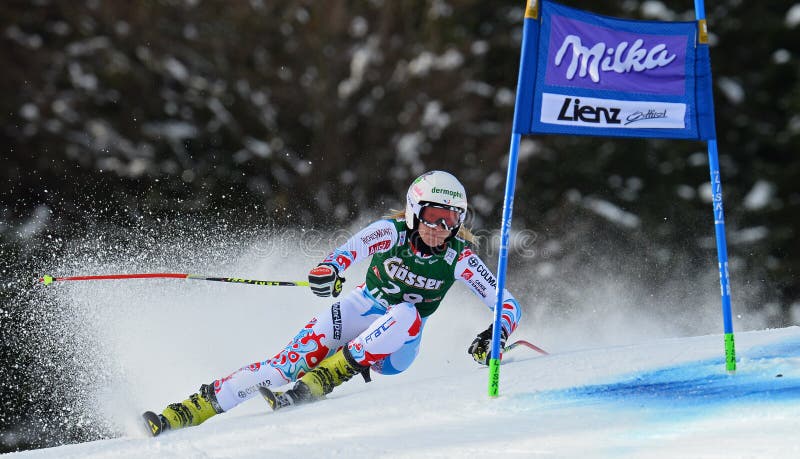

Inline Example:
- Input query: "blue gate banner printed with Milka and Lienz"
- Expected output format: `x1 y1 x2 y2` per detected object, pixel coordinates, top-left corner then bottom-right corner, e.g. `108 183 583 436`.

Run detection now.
514 1 715 140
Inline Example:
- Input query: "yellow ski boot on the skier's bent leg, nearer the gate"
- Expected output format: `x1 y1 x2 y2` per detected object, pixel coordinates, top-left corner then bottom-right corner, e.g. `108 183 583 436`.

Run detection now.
258 346 369 410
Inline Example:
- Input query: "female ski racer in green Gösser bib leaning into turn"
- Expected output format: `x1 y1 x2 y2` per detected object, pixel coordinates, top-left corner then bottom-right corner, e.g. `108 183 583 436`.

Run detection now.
144 171 521 435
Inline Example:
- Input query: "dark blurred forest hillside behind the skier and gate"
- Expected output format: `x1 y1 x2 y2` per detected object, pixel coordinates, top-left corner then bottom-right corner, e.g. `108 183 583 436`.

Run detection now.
0 0 800 451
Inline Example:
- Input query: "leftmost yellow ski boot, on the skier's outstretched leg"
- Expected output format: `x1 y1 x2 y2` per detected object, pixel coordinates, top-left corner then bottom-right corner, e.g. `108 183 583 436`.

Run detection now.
142 384 222 437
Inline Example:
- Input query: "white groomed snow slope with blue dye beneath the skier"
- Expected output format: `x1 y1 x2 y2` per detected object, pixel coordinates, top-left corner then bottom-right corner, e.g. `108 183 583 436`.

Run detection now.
9 327 800 458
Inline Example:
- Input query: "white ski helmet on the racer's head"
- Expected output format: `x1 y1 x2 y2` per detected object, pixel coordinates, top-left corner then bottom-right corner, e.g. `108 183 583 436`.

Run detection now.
406 171 467 231
